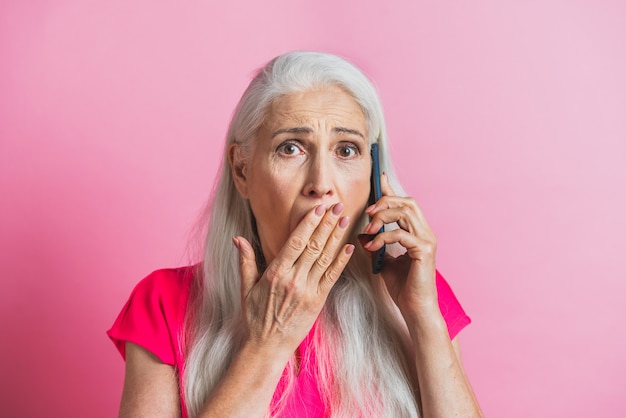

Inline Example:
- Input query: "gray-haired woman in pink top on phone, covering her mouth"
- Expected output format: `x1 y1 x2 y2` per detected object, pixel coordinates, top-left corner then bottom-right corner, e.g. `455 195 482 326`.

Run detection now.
108 52 481 417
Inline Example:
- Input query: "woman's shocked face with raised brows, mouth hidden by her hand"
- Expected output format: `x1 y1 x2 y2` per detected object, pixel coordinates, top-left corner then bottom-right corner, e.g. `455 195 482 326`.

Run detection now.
229 87 371 263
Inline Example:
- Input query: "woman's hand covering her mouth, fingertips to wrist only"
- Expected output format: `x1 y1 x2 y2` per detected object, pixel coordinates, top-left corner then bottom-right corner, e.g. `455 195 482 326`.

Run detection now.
233 203 354 358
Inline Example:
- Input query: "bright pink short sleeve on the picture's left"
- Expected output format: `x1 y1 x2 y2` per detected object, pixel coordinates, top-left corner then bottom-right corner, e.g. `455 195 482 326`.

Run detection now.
107 267 191 366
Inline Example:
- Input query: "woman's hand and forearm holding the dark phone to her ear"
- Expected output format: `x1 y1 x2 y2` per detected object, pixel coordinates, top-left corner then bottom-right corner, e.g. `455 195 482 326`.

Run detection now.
359 174 483 417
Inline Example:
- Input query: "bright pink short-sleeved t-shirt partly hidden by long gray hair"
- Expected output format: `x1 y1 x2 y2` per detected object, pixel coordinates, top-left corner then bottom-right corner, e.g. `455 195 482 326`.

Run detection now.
107 266 470 418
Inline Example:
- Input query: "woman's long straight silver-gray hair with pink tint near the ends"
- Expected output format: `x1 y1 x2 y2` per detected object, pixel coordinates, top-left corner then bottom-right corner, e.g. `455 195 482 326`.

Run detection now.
183 52 419 417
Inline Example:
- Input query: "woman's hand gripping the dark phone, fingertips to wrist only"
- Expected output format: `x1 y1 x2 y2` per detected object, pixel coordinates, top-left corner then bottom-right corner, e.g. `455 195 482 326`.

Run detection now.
363 174 439 319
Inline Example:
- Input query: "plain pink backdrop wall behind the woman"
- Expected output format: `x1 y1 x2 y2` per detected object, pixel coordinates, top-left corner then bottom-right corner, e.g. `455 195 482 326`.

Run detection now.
0 0 626 418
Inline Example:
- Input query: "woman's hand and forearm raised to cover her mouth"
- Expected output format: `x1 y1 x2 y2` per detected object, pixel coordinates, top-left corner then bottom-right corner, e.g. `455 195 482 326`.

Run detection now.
198 203 354 418
